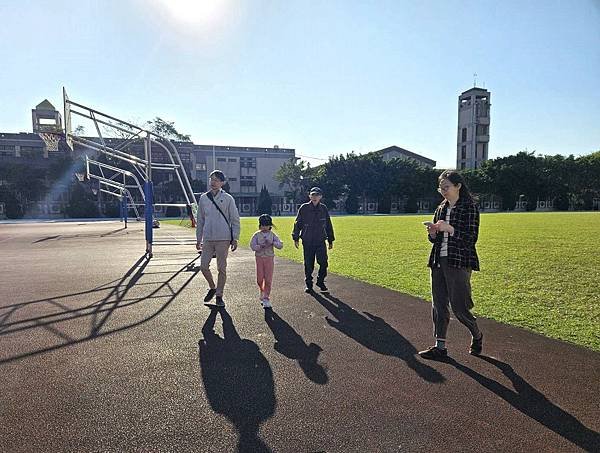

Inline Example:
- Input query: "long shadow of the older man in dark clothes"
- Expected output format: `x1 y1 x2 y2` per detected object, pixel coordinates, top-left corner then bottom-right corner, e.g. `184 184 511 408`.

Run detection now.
312 293 445 384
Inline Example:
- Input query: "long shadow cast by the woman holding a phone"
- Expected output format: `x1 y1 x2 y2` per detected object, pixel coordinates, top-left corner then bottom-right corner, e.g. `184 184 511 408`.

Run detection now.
446 355 600 451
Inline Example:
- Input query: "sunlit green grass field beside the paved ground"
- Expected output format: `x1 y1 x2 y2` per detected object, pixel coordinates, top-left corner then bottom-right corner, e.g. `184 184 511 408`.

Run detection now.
164 212 600 351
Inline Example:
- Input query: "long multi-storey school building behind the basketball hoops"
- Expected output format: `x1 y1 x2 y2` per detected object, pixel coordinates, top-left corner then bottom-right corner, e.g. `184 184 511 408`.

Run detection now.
0 100 296 217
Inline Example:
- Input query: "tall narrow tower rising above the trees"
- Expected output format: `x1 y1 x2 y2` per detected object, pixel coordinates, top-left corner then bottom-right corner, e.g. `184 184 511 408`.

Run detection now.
456 87 491 170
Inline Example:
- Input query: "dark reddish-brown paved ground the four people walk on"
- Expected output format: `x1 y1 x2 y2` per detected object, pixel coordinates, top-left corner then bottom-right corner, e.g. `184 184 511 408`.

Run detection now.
0 222 600 452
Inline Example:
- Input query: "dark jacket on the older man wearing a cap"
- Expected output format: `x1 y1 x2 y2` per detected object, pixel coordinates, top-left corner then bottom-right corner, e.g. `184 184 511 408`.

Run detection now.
292 202 335 245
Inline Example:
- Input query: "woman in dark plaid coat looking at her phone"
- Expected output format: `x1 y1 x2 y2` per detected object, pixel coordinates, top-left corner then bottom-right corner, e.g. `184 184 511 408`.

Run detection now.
419 170 483 359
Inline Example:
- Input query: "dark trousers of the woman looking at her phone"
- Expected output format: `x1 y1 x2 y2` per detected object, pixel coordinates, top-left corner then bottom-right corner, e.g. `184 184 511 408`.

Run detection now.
431 257 481 339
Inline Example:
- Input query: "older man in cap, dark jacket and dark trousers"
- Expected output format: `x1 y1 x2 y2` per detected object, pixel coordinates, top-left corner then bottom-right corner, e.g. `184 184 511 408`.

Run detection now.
292 187 335 293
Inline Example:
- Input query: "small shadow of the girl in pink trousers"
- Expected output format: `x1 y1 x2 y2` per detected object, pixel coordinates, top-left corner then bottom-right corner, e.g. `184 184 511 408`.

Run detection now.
265 309 329 384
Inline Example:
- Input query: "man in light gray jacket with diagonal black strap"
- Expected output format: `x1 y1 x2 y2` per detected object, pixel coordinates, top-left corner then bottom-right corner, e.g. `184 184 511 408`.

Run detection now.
196 170 240 307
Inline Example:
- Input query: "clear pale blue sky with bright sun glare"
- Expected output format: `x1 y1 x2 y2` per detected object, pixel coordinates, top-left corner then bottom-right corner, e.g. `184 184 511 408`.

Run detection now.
0 0 600 168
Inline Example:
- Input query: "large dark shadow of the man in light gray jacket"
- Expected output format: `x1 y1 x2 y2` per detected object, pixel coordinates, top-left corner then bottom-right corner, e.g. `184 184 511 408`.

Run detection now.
198 308 276 452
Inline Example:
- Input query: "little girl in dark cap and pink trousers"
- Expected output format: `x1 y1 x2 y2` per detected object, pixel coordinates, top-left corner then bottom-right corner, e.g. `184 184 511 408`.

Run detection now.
250 214 283 308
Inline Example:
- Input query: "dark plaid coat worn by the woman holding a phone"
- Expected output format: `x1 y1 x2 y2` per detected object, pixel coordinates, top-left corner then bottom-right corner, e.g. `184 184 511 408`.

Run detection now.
427 198 479 271
